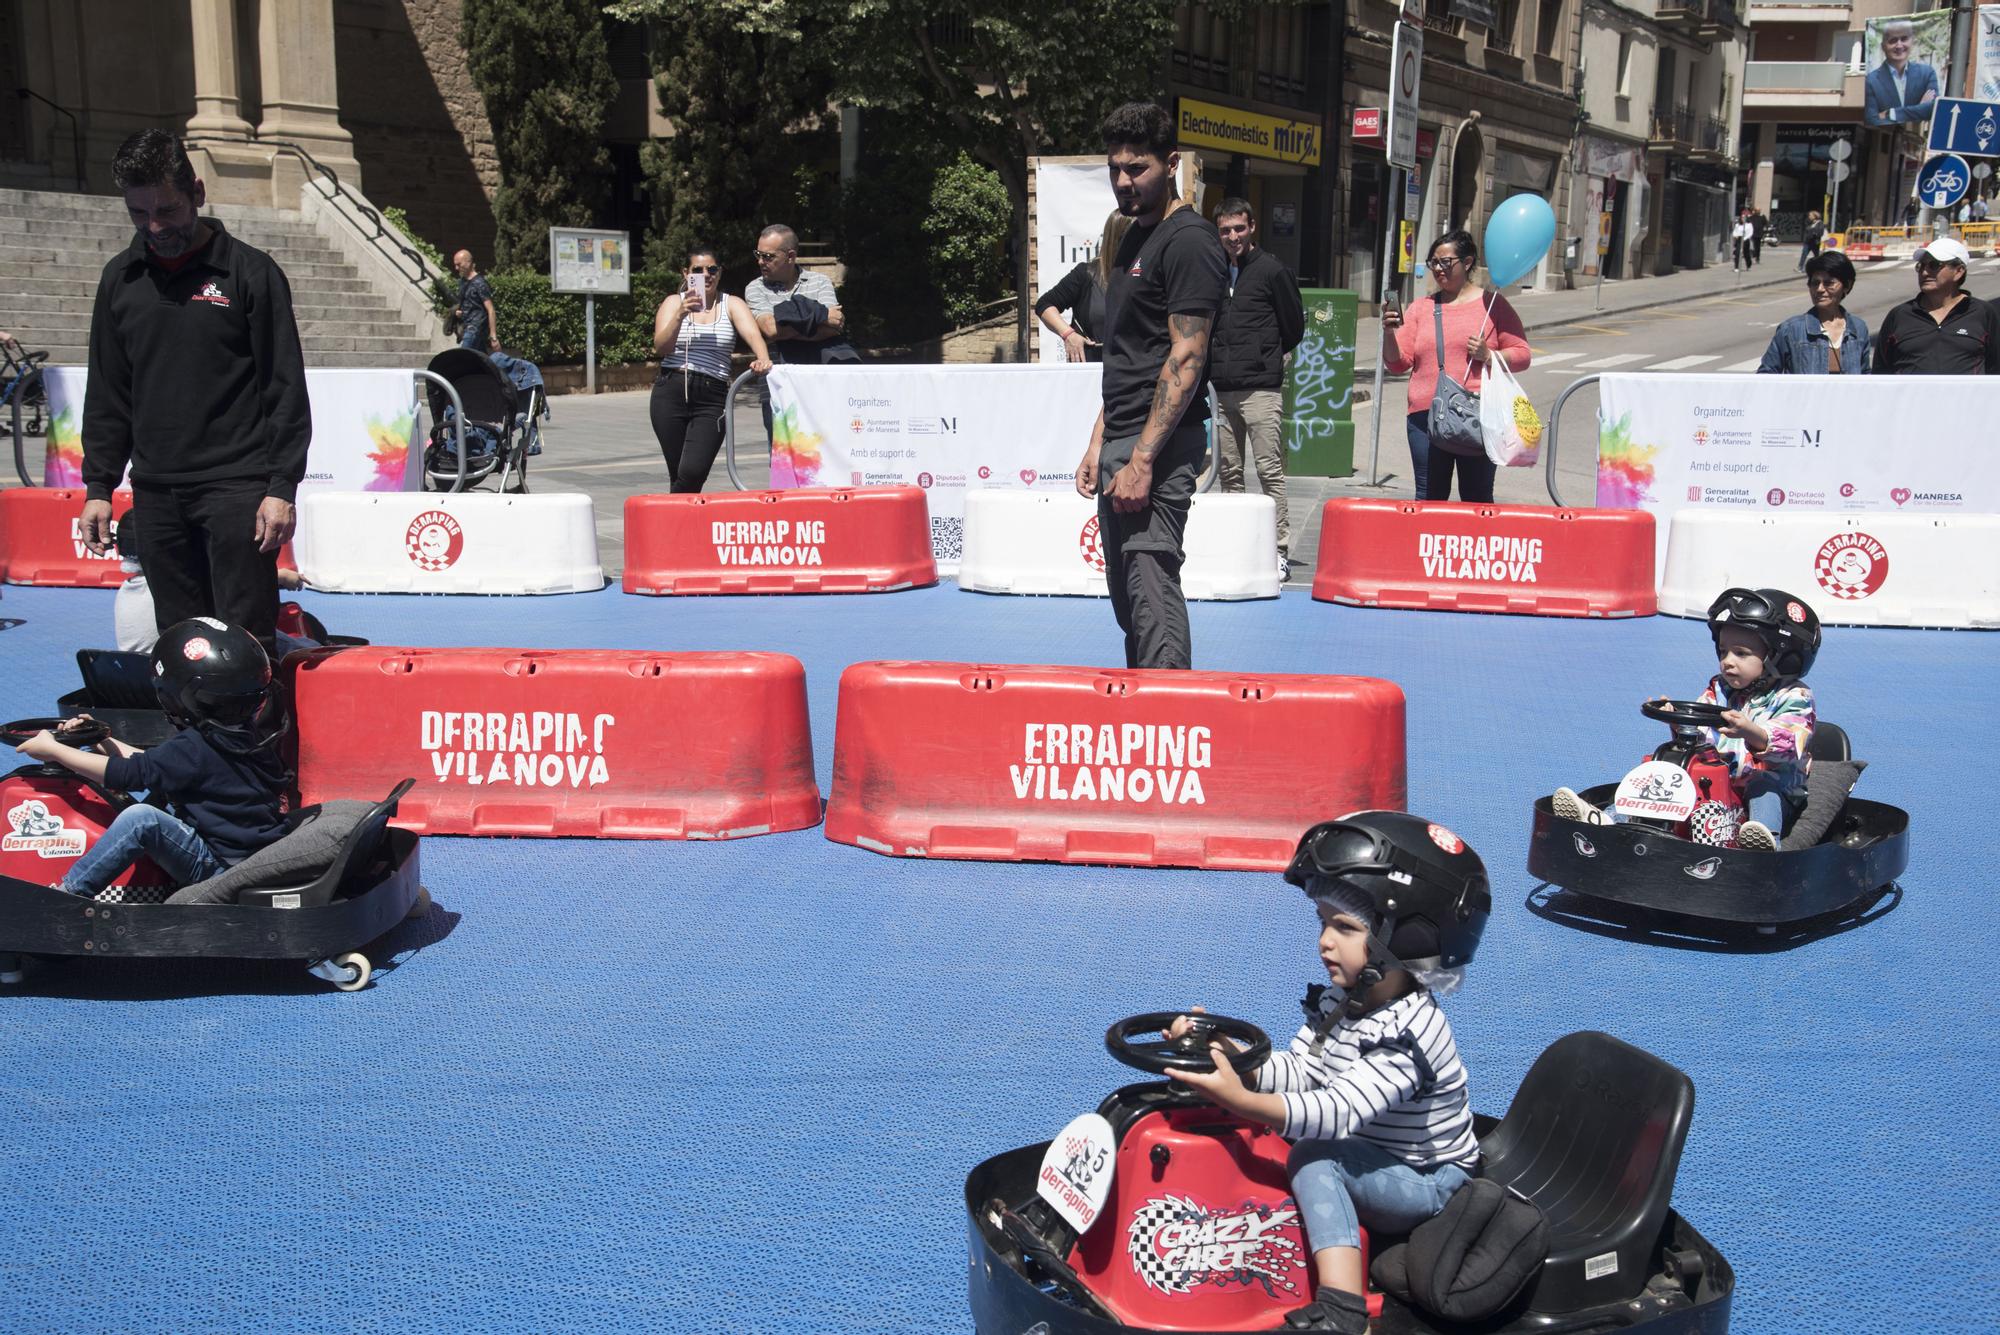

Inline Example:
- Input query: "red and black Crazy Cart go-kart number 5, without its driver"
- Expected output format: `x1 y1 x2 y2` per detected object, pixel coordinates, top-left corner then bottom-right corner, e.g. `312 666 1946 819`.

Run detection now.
966 1011 1736 1335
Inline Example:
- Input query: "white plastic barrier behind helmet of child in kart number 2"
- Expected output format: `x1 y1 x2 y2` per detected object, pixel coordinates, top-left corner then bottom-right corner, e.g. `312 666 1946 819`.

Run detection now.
1660 508 2000 630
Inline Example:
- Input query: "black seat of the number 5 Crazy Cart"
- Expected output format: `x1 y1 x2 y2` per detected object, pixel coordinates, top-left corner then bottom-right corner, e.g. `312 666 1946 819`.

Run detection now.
1480 1031 1694 1313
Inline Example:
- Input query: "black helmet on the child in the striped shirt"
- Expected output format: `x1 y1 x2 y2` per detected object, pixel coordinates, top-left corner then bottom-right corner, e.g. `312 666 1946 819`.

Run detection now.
1284 811 1494 969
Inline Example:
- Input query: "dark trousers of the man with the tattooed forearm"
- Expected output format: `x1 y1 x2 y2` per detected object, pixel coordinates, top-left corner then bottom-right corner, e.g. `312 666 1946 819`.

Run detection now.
1098 422 1206 668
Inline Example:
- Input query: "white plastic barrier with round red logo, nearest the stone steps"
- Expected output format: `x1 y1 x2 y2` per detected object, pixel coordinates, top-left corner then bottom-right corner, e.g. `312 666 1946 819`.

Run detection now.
292 492 604 594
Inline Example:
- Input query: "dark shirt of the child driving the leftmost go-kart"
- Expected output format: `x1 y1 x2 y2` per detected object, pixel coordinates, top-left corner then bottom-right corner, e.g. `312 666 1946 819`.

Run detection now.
104 727 286 867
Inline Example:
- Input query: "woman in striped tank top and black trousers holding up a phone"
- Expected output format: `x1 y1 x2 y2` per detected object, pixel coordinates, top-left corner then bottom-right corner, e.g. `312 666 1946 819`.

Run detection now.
652 246 770 492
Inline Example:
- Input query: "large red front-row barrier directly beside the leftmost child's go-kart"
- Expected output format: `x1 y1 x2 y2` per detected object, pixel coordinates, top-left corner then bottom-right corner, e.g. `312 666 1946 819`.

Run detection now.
286 648 820 839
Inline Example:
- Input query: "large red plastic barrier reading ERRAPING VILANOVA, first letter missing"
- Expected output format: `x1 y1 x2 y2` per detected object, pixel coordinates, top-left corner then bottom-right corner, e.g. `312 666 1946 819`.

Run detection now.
826 664 1404 871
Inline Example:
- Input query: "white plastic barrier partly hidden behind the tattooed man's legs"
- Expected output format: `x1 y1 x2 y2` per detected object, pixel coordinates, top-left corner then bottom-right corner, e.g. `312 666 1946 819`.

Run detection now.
958 490 1280 602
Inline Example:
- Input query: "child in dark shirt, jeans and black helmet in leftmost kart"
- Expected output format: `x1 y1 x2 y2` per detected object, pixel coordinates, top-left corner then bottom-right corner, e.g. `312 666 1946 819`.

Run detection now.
16 618 290 897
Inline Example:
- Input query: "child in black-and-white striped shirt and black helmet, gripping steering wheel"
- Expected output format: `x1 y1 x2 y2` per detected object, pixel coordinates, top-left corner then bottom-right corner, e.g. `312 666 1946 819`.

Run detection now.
1168 811 1492 1335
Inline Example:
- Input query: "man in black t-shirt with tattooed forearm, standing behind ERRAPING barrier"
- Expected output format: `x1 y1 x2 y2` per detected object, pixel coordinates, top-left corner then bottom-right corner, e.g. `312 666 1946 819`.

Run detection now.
1076 102 1228 668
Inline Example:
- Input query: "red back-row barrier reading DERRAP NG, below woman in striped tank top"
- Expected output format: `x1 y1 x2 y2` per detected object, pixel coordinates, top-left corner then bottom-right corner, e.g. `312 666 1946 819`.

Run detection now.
624 488 938 594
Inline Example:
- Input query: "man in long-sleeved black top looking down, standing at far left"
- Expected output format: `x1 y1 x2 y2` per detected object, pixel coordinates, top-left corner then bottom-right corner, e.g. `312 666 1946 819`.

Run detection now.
82 130 312 654
